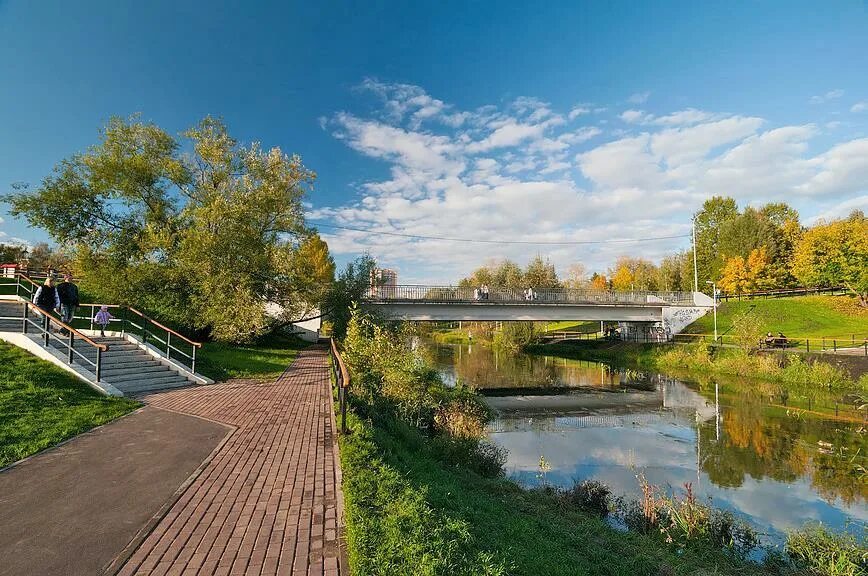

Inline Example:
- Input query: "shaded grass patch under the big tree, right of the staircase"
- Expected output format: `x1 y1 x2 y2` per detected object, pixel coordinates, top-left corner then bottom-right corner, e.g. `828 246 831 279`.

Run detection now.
196 334 308 381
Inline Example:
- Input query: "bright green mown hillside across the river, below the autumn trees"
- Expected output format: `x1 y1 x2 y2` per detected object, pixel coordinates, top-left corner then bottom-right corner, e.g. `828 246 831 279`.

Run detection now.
685 296 868 341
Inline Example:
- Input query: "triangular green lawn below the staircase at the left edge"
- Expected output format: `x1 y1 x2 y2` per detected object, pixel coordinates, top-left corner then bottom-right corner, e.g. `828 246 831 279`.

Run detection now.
0 342 140 467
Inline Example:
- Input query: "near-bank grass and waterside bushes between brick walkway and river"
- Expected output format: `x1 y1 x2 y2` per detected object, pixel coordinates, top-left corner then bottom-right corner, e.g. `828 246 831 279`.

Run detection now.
340 311 868 576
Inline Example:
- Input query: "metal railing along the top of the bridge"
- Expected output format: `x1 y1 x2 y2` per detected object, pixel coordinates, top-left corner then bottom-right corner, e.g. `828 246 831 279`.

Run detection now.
365 284 694 306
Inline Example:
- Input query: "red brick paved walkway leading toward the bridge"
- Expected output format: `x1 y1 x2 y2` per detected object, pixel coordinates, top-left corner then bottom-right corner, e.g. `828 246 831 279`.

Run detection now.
119 348 347 576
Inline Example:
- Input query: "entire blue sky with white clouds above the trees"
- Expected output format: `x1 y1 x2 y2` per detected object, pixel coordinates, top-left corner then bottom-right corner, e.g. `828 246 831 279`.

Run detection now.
0 0 868 282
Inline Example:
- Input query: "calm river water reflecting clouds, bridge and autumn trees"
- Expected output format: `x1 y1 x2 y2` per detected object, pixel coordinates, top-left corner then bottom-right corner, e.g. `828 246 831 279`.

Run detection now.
420 341 868 540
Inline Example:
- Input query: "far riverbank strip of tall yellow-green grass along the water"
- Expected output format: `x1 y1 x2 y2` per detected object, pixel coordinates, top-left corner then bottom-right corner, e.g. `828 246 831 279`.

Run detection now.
525 341 868 394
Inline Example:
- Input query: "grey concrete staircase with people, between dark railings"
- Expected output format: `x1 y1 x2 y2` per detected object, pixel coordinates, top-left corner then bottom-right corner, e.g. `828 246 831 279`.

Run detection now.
0 300 197 396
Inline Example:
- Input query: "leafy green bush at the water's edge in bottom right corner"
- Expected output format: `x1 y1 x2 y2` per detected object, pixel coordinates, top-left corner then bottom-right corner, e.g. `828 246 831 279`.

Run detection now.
786 524 868 576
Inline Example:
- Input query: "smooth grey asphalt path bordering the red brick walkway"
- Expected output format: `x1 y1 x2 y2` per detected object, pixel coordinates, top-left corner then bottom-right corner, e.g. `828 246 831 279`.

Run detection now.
0 406 232 576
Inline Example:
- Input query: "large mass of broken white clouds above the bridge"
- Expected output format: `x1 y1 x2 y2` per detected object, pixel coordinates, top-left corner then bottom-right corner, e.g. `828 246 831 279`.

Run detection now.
311 80 868 282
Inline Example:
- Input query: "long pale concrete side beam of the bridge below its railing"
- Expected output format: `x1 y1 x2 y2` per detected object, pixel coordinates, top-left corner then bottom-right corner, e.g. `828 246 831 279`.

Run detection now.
362 302 664 322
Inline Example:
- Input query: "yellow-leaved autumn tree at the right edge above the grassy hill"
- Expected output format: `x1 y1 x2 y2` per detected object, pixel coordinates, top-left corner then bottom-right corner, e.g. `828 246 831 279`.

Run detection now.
793 211 868 307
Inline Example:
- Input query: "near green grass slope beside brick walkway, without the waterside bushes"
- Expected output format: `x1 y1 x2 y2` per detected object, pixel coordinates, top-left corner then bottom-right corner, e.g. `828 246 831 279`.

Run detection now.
341 404 759 576
